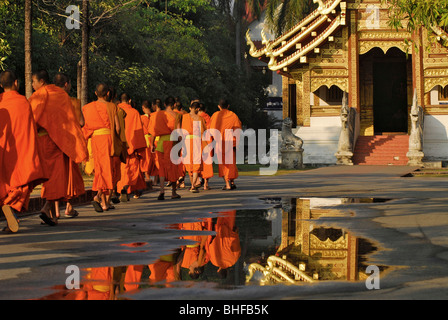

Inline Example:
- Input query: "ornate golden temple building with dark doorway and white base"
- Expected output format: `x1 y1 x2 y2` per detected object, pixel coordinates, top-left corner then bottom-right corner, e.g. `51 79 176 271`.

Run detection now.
246 0 448 166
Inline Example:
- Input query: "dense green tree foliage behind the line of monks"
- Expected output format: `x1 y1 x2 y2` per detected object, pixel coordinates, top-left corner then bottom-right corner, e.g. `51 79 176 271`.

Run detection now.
0 0 270 129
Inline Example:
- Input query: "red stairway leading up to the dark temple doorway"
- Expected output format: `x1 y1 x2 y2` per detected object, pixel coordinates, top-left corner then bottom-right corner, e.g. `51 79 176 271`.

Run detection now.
353 134 409 166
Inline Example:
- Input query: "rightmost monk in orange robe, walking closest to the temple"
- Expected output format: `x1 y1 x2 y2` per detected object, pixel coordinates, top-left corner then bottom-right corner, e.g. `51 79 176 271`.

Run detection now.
210 99 242 190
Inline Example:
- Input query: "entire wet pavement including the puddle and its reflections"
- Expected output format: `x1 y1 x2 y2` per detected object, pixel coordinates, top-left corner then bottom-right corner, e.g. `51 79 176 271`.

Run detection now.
0 166 448 300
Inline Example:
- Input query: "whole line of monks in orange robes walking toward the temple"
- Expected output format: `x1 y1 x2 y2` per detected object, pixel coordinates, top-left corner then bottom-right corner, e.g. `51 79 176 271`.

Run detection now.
0 70 241 233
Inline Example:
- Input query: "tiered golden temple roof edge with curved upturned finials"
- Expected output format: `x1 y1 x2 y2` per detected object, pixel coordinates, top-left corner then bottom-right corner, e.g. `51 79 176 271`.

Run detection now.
246 0 347 71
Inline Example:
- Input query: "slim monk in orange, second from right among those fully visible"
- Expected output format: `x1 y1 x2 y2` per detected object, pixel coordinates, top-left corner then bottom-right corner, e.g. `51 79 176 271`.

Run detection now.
181 102 206 193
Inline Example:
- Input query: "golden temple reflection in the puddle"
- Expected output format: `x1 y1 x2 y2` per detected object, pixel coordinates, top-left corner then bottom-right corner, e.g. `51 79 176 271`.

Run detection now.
248 198 378 284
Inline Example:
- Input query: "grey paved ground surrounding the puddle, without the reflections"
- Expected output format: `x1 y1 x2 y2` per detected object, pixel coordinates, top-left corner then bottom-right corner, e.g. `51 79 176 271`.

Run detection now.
0 166 448 299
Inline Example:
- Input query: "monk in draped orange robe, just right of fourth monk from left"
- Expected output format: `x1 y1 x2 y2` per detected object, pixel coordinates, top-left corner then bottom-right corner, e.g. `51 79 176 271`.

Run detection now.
117 93 147 202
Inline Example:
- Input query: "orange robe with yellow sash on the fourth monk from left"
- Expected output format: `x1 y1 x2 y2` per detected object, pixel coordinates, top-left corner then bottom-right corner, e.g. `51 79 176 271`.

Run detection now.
82 101 114 191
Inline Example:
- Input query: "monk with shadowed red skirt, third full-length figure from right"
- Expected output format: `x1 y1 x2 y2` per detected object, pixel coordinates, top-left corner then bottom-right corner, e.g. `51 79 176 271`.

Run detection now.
148 97 181 200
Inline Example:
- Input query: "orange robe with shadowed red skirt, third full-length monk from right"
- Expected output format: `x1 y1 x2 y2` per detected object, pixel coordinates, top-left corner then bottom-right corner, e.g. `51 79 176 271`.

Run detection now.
148 110 180 182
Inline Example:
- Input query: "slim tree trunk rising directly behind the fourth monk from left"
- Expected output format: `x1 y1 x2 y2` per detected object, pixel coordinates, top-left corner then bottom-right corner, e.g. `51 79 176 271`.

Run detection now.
81 0 89 106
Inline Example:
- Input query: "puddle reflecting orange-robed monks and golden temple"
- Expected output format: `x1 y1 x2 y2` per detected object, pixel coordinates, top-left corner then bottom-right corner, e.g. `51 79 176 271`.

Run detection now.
42 198 388 300
